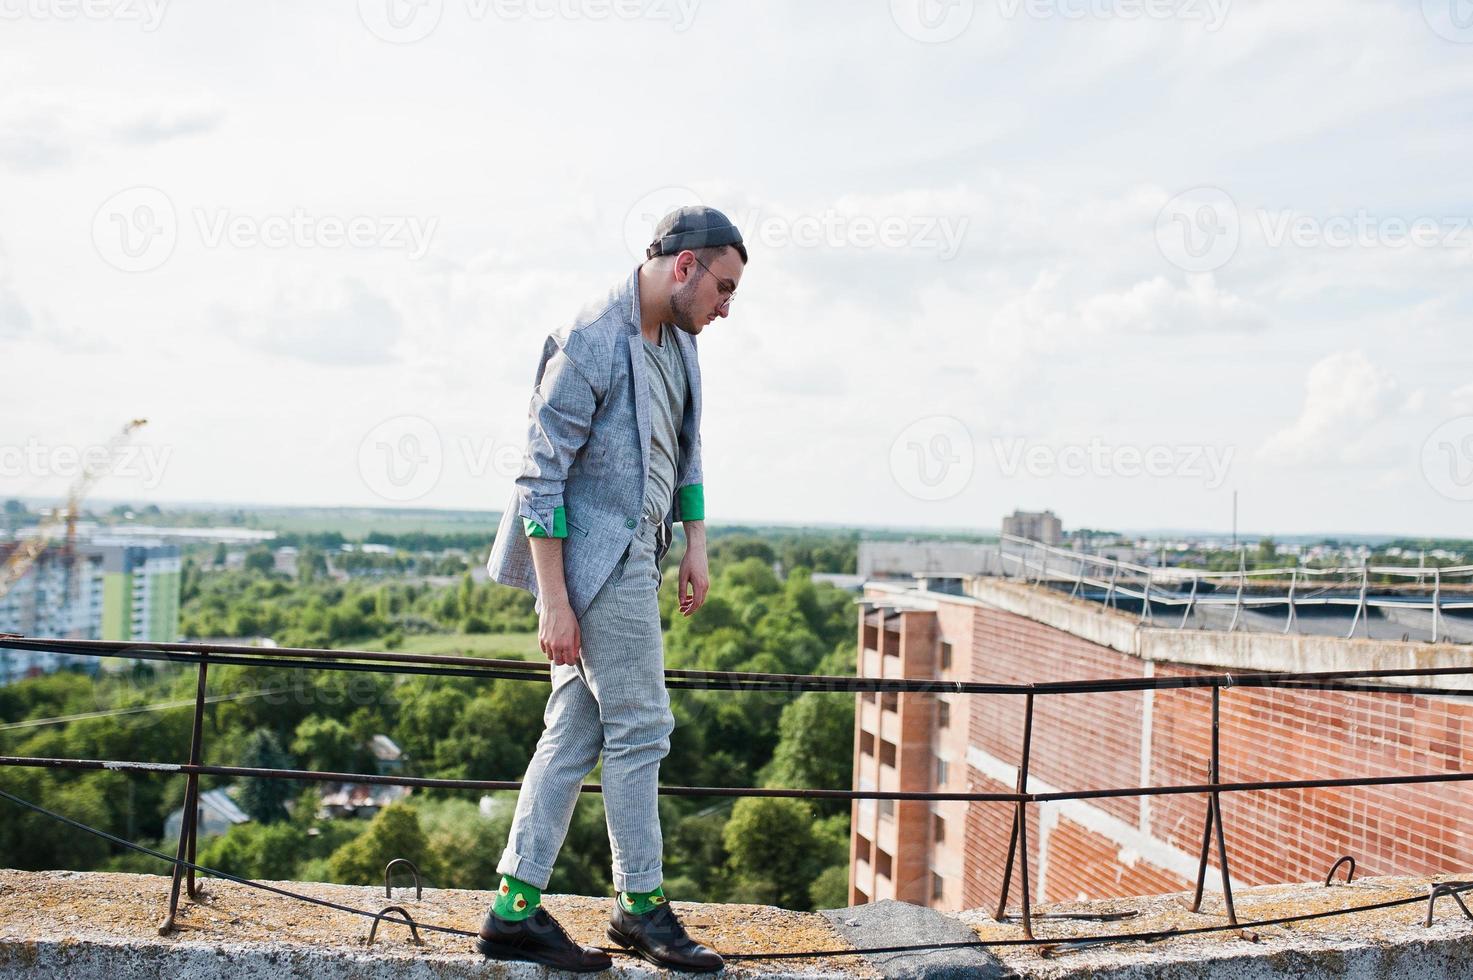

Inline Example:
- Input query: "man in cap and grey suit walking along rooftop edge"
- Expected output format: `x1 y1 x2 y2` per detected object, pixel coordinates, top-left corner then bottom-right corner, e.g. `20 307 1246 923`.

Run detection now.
477 206 747 971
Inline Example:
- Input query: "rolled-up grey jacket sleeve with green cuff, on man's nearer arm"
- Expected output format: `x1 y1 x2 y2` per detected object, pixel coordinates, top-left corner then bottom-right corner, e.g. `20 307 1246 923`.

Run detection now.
516 339 597 538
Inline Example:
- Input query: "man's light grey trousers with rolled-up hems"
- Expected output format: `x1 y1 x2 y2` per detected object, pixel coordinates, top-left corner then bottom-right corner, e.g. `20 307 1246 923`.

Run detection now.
496 519 675 892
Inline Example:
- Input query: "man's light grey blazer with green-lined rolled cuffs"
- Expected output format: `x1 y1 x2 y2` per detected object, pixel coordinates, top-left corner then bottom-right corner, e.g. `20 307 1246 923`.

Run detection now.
486 268 706 616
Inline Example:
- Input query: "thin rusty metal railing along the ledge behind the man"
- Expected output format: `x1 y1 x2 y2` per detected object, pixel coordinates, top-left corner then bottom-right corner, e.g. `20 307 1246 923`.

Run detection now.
0 635 1473 959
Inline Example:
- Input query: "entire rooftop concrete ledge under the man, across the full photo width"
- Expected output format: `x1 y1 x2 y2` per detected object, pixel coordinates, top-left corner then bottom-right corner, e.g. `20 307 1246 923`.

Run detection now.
0 871 1473 980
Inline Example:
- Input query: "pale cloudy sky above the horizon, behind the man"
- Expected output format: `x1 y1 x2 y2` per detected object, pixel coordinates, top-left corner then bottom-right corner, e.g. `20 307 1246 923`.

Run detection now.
0 0 1473 536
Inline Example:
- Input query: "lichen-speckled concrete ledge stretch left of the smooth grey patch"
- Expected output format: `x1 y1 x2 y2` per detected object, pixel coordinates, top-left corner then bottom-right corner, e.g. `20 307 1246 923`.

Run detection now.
0 871 878 980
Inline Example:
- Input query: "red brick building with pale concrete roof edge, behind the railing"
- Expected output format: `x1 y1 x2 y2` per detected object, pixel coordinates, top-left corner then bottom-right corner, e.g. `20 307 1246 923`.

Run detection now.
850 578 1473 909
